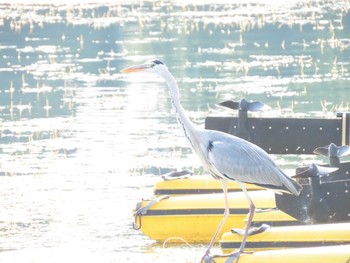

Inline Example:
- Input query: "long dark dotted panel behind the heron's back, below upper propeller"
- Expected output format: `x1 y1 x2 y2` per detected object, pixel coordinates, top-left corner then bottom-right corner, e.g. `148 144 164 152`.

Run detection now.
205 113 350 154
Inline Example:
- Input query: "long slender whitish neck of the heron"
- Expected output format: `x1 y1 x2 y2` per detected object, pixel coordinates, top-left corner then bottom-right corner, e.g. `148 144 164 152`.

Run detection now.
163 71 196 146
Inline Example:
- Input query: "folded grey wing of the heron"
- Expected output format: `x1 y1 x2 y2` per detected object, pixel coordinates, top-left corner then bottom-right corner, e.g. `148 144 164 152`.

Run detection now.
208 136 286 188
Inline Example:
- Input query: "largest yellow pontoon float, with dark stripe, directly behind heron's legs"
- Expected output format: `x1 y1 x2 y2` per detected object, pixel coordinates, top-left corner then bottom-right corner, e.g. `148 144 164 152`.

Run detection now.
134 190 297 242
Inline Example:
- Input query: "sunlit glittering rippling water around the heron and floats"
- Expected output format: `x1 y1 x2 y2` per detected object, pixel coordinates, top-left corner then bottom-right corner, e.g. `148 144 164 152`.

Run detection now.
0 0 350 262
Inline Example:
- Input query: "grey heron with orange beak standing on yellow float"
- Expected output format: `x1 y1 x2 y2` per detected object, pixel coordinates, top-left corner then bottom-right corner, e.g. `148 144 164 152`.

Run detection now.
121 60 301 262
